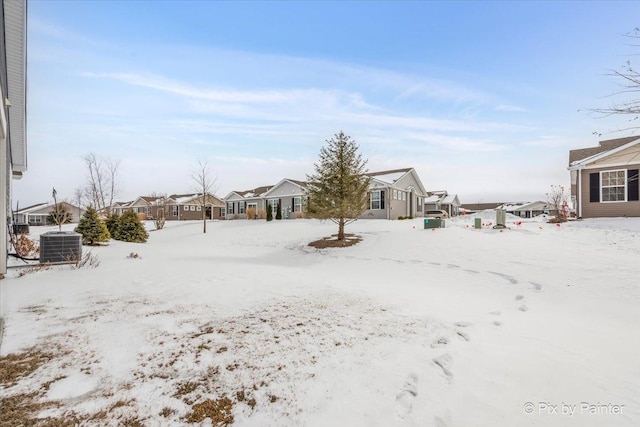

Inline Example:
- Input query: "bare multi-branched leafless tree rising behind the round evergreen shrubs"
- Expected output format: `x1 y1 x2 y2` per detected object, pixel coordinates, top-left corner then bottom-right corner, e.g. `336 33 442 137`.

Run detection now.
82 153 120 215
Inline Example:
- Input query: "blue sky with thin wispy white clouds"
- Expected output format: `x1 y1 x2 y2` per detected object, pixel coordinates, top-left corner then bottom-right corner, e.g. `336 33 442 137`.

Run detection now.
13 1 640 207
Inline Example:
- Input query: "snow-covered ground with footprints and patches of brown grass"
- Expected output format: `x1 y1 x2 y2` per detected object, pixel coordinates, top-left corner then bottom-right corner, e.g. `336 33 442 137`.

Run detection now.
0 216 640 427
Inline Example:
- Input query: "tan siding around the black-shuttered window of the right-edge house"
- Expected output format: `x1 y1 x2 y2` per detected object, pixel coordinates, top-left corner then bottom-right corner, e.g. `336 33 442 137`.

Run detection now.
576 166 640 218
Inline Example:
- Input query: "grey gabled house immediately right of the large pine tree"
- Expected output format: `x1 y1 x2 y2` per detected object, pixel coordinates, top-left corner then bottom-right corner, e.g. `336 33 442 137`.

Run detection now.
360 168 427 219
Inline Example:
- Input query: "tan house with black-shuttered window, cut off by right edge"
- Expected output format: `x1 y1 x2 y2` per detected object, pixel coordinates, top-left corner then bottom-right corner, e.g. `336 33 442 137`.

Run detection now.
568 136 640 218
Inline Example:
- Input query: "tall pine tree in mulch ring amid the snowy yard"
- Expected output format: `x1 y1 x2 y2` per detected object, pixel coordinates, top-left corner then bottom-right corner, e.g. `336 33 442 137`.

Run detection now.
307 131 370 240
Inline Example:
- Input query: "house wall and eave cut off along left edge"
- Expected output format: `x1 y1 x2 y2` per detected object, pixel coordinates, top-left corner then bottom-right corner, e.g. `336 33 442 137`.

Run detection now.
0 0 27 278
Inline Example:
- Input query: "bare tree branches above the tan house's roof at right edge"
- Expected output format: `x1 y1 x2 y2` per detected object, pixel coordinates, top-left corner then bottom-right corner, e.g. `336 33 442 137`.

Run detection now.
589 27 640 136
